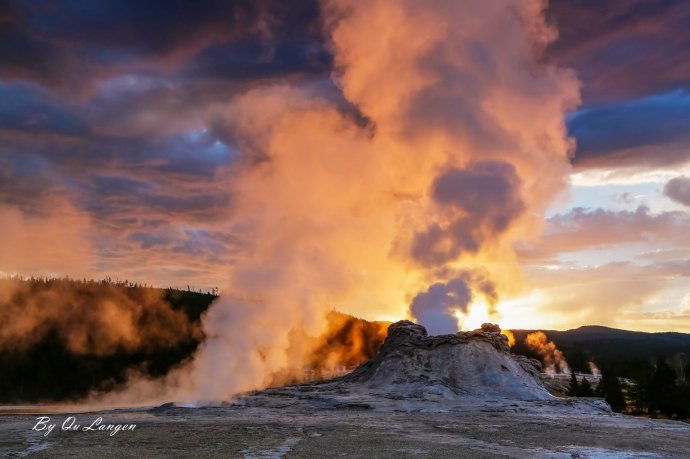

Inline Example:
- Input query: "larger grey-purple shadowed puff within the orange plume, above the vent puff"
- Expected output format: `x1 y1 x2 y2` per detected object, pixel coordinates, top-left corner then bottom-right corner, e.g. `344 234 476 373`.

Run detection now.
412 161 525 265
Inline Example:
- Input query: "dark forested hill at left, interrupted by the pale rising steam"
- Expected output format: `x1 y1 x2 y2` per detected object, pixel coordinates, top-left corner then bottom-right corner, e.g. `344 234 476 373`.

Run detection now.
0 279 388 403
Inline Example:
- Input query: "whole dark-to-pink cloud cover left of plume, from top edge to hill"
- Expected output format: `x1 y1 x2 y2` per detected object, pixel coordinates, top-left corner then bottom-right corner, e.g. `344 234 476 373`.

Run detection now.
0 0 334 287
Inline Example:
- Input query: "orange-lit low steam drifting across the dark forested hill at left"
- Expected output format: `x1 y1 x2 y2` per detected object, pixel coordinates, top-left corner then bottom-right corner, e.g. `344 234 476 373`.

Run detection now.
0 279 201 356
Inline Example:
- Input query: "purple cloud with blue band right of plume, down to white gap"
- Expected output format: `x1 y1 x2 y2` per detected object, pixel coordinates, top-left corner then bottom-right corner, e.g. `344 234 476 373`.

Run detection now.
546 0 690 168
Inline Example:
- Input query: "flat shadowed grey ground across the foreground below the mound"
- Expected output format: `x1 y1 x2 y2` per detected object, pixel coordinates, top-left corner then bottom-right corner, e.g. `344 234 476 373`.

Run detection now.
0 393 690 458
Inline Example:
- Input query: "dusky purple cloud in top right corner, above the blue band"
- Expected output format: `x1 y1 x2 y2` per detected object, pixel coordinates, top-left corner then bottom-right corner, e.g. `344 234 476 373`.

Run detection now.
547 0 690 106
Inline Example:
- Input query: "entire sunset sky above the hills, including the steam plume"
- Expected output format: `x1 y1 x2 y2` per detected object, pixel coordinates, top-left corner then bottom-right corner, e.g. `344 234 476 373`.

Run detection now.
0 0 690 332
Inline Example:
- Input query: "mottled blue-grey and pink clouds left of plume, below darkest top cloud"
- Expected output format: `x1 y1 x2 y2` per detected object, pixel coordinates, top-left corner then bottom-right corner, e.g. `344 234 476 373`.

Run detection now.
0 74 241 287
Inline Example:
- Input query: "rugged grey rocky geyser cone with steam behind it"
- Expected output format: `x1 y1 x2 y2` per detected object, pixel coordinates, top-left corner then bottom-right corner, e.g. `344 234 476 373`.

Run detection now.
339 320 551 400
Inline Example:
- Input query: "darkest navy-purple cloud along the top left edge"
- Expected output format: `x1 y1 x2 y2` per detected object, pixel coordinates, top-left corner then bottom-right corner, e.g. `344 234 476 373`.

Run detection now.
0 0 327 91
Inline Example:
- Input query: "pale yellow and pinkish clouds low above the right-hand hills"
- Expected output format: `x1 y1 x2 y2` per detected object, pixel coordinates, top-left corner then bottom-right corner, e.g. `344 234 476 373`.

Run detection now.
518 206 690 331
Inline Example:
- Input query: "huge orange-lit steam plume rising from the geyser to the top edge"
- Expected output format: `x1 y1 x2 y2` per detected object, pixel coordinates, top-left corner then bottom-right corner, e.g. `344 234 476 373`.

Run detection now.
117 0 579 400
